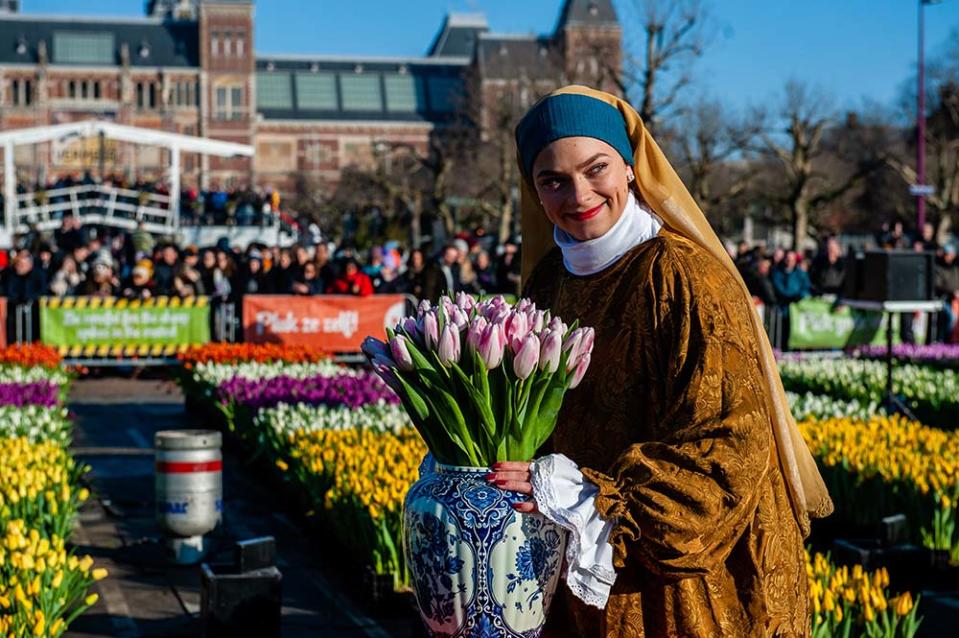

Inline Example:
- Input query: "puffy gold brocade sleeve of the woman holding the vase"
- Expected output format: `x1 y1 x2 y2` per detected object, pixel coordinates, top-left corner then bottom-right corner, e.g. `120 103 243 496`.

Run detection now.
583 244 775 578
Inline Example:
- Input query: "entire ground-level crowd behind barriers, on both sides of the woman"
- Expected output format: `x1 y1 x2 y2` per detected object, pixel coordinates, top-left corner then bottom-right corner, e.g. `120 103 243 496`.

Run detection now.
0 211 959 345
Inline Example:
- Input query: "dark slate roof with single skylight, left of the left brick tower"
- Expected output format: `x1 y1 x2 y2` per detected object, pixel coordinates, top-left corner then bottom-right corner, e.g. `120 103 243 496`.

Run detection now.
0 14 200 67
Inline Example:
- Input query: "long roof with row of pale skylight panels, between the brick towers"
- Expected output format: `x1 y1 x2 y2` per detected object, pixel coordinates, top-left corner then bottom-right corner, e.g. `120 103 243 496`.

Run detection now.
256 54 469 123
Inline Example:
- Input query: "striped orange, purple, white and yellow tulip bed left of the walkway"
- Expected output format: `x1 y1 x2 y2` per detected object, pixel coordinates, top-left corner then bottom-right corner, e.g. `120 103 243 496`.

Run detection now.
0 347 106 638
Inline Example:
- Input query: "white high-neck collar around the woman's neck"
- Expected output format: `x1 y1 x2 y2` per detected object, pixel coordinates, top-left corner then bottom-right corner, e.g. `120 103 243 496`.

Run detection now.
553 193 663 276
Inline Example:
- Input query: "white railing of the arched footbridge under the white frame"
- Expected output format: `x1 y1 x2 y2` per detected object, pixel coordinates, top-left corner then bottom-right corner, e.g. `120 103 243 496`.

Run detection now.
13 184 178 234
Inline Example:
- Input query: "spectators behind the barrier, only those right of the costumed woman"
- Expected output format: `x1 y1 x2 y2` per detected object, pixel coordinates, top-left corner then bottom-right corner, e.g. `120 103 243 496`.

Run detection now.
728 222 959 345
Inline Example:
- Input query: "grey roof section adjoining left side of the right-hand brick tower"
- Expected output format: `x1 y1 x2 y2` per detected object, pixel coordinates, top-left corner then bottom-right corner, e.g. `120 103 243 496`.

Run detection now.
476 33 563 80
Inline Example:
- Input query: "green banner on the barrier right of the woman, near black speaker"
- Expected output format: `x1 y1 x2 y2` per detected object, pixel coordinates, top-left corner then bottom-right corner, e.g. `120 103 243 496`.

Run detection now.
789 297 899 350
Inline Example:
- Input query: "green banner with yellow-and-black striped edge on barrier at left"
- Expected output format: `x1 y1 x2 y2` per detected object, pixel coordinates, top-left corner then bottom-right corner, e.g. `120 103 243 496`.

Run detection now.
40 297 210 346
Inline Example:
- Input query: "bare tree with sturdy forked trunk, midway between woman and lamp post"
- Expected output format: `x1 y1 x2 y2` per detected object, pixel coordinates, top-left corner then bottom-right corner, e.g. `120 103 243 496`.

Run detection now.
757 81 885 249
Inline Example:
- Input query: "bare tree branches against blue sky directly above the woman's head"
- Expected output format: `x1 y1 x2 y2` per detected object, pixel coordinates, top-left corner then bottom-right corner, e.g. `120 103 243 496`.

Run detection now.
617 0 709 131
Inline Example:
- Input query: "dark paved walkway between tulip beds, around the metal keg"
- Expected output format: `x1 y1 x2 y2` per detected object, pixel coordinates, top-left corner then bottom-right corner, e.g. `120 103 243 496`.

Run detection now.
67 378 418 638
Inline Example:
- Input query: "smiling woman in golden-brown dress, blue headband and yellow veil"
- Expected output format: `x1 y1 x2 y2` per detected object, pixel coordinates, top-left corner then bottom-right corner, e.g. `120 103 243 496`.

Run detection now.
489 86 832 638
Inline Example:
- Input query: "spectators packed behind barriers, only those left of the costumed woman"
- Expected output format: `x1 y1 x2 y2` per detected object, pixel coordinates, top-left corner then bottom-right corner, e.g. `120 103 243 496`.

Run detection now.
0 215 520 312
